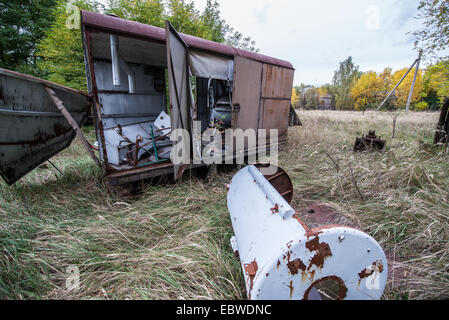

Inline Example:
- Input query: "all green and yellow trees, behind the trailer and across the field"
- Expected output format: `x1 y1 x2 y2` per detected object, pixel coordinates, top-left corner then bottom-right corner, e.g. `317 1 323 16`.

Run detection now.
0 0 449 110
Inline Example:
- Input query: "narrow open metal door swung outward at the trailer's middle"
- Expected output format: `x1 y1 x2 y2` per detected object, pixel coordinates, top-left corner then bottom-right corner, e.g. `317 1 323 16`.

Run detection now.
166 21 191 180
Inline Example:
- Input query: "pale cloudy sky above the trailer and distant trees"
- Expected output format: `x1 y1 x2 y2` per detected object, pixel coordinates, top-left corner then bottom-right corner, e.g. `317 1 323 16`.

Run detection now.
195 0 422 85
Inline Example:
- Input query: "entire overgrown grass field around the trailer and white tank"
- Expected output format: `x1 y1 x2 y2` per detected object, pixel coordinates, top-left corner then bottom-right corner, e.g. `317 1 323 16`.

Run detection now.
0 111 449 299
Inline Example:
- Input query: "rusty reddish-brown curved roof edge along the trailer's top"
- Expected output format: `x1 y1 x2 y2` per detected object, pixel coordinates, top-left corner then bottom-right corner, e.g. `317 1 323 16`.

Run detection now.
81 10 294 69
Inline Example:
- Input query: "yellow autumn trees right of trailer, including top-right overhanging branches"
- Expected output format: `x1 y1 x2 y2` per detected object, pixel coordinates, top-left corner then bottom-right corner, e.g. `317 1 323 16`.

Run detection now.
292 0 449 111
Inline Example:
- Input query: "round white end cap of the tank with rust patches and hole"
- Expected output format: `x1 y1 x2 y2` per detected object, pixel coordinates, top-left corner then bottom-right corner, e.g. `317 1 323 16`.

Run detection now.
251 226 388 300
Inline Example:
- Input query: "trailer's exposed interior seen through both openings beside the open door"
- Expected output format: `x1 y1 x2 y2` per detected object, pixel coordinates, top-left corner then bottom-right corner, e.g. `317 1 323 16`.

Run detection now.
85 32 233 175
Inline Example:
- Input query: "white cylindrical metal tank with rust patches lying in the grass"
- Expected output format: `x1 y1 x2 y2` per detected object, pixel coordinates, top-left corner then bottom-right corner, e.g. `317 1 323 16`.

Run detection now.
227 165 388 300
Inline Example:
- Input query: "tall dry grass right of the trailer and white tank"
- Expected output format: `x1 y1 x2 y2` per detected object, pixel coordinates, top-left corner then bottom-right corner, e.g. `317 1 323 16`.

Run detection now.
281 111 449 299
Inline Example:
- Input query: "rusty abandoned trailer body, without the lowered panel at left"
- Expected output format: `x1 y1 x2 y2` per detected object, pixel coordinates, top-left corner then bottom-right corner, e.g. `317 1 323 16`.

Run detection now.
81 11 294 185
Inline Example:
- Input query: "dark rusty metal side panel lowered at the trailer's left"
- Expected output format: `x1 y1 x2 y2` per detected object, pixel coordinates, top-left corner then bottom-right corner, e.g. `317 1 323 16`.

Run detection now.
0 69 91 185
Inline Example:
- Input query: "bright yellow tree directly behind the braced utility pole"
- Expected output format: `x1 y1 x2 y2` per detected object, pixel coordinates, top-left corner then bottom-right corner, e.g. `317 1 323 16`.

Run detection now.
390 68 424 109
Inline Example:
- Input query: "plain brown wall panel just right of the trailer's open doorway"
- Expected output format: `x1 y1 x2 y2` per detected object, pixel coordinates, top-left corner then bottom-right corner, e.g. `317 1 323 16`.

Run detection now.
232 56 263 130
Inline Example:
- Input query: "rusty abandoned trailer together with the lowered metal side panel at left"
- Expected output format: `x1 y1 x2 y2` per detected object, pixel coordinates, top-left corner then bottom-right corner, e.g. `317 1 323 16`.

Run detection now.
0 11 300 185
